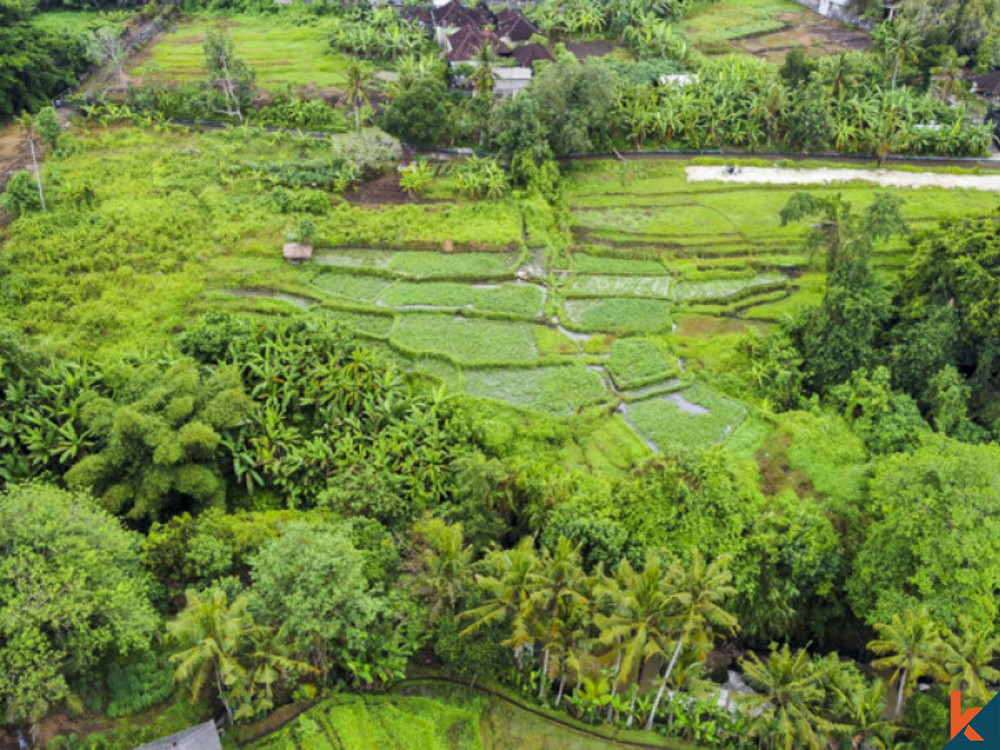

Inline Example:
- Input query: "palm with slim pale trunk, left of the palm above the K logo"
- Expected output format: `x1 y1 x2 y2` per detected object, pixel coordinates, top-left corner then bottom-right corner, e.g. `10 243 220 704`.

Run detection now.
868 610 948 718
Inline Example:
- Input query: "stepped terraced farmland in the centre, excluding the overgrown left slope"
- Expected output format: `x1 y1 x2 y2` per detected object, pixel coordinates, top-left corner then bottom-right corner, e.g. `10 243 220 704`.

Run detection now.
227 161 995 458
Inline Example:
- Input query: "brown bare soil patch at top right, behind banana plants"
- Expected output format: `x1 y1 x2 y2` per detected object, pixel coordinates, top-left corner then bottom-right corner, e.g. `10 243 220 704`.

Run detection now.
736 13 871 63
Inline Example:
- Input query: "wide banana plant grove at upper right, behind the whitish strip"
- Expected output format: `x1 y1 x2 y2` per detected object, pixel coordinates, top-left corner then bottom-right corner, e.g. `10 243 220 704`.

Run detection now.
618 55 992 160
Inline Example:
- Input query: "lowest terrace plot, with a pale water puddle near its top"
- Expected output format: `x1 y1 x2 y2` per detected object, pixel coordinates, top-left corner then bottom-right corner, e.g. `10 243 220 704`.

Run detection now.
628 385 746 448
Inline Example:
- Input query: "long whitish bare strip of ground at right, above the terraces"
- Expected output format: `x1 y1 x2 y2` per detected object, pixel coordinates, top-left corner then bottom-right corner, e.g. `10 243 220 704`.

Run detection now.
686 167 1000 193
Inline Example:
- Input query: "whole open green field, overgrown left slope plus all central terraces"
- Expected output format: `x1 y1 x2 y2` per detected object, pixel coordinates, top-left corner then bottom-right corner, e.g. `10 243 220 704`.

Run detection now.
7 123 1000 470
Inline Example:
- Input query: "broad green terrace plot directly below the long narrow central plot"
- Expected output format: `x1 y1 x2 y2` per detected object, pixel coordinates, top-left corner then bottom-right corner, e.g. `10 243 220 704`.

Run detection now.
389 313 538 367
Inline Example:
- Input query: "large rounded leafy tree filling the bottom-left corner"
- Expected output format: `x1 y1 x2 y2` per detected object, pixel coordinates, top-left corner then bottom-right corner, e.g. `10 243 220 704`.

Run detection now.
0 485 156 721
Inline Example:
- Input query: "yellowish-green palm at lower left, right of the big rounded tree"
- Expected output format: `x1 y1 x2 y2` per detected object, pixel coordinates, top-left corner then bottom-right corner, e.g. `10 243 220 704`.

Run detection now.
167 588 253 723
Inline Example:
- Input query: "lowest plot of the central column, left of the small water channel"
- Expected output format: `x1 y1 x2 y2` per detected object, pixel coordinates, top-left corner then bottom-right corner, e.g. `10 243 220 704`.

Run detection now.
464 365 609 414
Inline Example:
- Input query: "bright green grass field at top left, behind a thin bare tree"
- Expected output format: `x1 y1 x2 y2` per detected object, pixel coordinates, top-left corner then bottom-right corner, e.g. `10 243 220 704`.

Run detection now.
141 14 356 89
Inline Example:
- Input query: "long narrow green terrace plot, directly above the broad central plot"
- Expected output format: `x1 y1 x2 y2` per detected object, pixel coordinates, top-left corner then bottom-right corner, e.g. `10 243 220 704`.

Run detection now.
378 281 545 318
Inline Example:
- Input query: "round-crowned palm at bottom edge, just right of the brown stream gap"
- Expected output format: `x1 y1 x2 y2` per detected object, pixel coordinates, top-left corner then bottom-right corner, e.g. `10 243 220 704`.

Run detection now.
740 643 832 750
